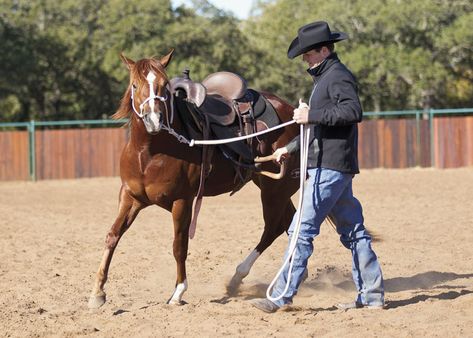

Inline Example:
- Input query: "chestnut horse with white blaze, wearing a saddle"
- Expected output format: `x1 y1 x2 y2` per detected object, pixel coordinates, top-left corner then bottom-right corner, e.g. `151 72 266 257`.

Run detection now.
89 50 299 308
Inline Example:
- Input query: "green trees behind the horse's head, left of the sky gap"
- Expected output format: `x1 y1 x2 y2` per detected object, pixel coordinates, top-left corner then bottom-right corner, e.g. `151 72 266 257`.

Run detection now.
0 0 259 120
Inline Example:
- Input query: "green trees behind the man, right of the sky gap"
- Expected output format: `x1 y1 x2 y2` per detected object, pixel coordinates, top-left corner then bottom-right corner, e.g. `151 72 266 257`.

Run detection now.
245 0 473 110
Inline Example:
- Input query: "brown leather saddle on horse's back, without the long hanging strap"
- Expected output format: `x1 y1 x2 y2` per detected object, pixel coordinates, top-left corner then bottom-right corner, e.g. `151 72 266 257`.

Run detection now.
170 70 279 165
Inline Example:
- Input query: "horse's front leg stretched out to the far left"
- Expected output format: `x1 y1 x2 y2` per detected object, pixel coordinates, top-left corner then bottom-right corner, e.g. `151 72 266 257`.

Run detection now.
88 186 144 308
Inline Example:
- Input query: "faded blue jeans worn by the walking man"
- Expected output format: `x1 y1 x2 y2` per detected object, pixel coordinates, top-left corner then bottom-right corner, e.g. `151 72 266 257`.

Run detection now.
271 168 384 306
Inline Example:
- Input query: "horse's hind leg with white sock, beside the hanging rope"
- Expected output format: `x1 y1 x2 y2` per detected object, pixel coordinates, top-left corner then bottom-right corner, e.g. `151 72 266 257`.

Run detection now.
227 185 296 296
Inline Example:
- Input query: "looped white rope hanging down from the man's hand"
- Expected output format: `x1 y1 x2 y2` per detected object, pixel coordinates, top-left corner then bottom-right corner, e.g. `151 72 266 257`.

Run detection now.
266 124 310 302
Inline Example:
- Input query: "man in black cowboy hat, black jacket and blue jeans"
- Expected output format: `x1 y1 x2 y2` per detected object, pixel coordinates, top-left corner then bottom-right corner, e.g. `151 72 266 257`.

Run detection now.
251 21 384 312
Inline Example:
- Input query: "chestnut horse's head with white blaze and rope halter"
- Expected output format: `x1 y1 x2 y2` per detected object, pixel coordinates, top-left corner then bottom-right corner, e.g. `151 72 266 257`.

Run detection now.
114 50 174 134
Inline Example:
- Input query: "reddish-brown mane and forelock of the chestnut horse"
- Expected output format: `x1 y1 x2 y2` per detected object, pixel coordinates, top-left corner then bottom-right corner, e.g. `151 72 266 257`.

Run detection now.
112 58 168 120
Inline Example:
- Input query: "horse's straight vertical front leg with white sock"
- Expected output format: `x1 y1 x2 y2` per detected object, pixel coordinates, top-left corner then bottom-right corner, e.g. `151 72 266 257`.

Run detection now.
168 200 192 305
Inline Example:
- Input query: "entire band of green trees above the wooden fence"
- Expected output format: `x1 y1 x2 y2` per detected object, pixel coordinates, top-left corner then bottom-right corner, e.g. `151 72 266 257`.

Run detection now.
0 0 473 121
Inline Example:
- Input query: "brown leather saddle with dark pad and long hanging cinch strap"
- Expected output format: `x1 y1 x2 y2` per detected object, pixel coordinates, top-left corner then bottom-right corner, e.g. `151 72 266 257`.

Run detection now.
170 69 279 233
